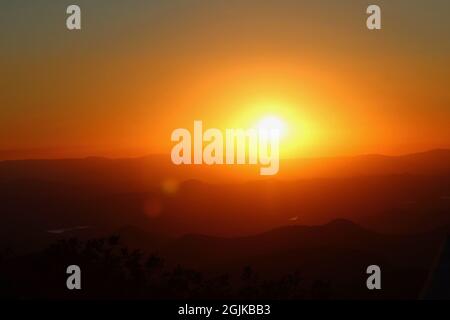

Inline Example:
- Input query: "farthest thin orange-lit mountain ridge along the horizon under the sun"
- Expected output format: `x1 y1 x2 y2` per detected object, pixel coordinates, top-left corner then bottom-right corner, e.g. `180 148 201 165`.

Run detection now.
0 149 450 188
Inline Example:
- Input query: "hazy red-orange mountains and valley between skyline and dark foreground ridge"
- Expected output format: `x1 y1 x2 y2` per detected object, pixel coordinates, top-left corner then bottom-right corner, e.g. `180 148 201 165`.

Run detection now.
0 150 450 246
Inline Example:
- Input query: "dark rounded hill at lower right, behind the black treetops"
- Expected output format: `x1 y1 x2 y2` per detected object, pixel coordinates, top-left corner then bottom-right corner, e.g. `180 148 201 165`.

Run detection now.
156 219 445 298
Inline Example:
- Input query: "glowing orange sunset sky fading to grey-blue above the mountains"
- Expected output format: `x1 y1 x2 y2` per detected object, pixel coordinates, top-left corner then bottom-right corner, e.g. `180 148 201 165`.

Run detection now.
0 0 450 159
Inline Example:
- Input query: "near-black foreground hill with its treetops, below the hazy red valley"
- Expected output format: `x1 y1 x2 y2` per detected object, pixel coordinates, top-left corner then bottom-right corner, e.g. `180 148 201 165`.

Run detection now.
0 220 445 299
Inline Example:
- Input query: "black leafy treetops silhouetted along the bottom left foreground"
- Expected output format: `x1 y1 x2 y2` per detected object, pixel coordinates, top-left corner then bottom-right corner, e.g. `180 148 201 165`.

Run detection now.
0 235 331 299
